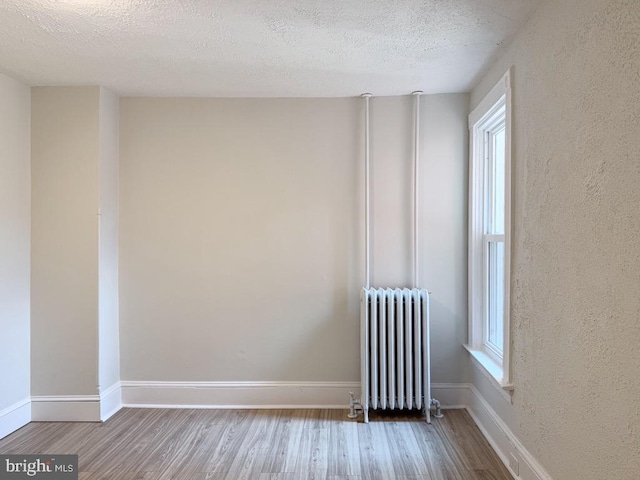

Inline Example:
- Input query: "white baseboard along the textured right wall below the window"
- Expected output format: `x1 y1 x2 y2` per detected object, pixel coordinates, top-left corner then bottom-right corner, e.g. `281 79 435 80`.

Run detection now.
467 384 552 480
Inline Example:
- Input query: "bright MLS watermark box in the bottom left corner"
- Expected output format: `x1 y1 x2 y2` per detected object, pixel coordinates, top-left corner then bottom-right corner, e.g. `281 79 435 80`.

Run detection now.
0 455 78 480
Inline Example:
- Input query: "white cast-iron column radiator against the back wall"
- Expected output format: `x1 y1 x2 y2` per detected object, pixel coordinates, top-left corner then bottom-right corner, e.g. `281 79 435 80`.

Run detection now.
360 288 431 423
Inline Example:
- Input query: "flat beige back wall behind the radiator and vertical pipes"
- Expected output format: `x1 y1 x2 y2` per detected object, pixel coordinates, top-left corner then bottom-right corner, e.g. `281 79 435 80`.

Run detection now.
120 95 468 381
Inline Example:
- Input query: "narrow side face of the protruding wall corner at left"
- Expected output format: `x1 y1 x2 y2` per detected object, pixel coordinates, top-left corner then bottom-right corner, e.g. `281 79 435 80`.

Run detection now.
98 88 120 393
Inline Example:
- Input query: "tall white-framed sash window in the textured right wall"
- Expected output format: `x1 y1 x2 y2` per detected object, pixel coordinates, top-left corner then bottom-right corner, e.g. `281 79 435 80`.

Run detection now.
465 68 512 390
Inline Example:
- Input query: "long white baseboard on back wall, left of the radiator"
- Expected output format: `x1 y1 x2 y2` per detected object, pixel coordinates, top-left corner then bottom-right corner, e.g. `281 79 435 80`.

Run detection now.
121 381 360 408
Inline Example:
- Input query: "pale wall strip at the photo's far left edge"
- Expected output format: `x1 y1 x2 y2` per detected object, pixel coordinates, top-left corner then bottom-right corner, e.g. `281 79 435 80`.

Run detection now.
0 74 31 412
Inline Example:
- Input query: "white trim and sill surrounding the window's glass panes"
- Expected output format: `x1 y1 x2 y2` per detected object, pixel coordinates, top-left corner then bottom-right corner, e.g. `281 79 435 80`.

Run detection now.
464 69 513 401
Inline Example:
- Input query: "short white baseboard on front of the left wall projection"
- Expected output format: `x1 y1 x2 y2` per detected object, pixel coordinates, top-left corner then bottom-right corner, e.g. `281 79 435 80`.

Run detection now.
31 395 100 422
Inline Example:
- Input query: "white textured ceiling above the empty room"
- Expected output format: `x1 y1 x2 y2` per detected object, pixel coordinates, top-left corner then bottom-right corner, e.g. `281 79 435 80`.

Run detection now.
0 0 543 97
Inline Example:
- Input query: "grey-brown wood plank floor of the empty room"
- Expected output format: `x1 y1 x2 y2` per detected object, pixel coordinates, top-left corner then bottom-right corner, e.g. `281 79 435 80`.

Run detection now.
0 408 511 480
